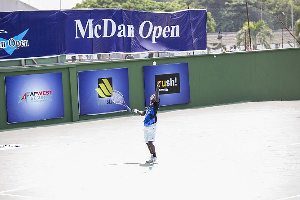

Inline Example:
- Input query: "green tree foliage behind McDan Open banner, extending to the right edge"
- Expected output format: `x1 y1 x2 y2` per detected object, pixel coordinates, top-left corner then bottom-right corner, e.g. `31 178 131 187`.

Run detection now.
74 0 300 32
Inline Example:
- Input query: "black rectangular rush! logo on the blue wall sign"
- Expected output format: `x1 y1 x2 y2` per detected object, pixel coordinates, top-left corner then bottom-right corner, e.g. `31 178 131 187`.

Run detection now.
155 73 180 94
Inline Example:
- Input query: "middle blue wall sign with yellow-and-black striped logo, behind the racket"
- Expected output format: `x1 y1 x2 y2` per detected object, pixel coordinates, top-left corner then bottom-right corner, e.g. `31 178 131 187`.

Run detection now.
78 68 129 115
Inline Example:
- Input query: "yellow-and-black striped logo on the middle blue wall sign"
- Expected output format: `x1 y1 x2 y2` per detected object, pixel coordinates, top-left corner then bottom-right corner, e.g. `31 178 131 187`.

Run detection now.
95 77 113 105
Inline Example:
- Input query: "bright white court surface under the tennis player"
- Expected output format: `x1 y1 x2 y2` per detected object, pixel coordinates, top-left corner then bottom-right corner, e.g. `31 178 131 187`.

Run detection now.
0 101 300 200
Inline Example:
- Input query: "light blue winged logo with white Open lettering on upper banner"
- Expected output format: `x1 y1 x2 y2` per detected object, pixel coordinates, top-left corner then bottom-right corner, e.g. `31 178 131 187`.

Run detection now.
0 29 29 55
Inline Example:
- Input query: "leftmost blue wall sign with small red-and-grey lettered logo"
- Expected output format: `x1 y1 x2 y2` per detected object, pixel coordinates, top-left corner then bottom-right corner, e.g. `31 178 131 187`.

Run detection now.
5 72 64 123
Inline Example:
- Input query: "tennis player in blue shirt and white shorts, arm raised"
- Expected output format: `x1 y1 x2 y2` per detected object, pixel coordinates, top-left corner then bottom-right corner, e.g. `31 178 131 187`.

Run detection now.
133 81 160 163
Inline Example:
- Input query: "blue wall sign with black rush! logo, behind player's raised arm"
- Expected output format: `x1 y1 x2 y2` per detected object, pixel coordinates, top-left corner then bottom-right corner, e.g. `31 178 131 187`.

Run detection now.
144 63 190 106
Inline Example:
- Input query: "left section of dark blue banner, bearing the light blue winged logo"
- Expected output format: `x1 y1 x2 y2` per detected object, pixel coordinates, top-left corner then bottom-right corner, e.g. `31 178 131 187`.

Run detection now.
0 11 66 59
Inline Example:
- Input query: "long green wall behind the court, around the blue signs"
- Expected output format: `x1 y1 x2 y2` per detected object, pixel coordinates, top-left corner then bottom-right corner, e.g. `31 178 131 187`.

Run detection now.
0 49 300 130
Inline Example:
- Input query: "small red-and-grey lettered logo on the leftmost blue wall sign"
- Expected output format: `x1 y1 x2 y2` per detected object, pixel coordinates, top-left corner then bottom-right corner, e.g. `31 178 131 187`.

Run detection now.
18 90 53 103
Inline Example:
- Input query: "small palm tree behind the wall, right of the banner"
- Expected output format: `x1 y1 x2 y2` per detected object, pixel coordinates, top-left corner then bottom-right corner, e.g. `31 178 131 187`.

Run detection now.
236 21 273 49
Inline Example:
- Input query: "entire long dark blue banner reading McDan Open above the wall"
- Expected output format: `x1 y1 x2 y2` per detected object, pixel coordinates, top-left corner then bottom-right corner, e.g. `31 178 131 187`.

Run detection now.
0 9 207 59
